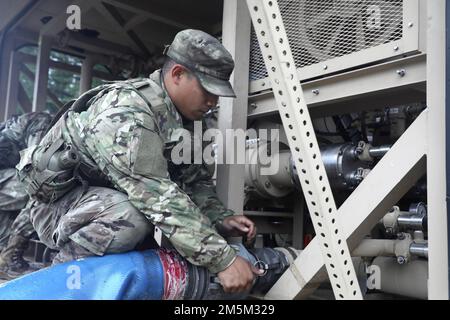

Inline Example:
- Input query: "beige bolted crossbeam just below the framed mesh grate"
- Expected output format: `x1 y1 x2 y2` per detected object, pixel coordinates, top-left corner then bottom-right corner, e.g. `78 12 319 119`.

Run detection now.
248 54 427 118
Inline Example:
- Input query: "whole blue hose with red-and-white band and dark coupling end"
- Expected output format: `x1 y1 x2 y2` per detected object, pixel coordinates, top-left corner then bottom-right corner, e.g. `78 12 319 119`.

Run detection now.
0 244 288 300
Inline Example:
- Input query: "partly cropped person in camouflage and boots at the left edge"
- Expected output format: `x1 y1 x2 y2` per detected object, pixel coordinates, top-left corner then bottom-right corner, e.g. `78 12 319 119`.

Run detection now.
0 112 51 279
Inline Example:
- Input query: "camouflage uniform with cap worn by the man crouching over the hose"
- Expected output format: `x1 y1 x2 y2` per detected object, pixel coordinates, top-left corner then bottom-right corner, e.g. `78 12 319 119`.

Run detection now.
22 30 236 273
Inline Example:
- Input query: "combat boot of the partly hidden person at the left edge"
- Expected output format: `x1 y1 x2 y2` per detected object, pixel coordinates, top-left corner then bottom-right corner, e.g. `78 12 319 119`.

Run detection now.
0 235 33 280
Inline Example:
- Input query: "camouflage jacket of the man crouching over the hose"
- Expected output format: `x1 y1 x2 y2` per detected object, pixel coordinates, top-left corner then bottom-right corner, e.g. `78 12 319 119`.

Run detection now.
59 71 236 273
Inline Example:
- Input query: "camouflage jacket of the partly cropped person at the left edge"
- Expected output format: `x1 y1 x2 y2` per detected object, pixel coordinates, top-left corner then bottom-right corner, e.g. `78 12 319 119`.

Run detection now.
0 112 52 169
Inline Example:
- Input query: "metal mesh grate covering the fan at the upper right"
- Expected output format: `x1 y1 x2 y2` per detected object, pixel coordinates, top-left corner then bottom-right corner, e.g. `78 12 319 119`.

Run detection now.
250 0 403 80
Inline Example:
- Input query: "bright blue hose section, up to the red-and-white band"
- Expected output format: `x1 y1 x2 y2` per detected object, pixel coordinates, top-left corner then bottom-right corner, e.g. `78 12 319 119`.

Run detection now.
0 250 164 300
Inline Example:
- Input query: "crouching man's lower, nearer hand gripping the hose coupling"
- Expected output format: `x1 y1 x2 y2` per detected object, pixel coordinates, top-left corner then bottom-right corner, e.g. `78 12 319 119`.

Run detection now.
217 256 264 293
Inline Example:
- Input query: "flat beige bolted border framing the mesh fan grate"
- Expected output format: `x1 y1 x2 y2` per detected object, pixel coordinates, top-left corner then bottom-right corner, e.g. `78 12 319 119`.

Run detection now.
250 0 419 94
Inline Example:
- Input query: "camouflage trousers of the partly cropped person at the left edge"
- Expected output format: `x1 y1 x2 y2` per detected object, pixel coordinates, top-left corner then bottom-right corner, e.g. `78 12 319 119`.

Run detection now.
0 169 33 250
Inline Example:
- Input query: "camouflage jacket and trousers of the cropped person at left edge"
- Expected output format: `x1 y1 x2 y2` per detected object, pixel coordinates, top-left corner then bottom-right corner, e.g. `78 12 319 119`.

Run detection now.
0 112 51 249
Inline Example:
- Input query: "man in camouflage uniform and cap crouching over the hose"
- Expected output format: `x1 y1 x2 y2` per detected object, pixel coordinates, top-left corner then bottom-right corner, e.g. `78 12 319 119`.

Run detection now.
17 30 261 292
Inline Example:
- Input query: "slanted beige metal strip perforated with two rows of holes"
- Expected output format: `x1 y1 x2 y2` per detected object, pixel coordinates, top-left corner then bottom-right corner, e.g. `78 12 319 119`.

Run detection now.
247 0 362 299
